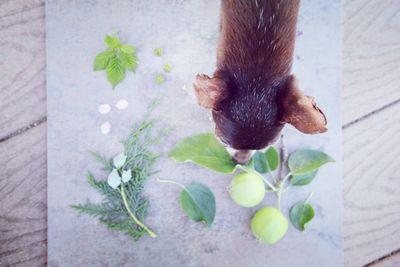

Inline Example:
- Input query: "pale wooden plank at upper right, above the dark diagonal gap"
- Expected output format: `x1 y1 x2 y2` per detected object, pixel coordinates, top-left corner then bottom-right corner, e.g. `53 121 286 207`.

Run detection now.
342 0 400 124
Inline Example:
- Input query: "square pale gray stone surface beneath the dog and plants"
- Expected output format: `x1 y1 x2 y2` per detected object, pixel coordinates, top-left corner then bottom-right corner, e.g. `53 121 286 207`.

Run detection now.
46 0 342 267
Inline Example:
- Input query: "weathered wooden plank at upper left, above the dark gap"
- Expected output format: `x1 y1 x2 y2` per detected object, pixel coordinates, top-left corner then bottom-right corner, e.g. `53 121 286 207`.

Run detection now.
0 0 46 139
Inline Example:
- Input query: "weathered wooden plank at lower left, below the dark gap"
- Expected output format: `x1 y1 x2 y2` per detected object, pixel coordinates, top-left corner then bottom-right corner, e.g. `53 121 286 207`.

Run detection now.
0 123 47 266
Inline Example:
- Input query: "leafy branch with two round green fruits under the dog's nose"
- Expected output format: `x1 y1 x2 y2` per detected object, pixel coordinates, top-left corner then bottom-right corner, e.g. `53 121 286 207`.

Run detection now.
169 133 334 244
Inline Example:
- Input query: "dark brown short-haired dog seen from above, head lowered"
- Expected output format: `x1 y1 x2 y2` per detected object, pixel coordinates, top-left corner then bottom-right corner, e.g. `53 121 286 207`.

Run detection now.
195 0 326 153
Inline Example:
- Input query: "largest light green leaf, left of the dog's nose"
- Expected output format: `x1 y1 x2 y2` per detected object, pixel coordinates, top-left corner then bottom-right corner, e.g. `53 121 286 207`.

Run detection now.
169 133 236 173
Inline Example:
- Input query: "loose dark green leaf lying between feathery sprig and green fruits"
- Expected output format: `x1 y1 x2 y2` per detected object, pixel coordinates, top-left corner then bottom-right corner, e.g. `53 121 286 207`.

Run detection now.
180 183 216 226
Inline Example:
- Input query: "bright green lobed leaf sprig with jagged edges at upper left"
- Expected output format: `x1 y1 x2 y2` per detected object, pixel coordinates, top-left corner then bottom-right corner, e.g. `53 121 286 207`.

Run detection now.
93 35 137 89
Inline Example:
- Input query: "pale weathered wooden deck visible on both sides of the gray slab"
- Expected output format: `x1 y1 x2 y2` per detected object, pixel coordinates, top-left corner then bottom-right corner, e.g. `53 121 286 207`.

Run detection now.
0 0 400 266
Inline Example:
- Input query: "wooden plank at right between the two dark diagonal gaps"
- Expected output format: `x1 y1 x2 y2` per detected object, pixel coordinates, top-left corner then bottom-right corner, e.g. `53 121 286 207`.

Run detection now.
343 103 400 266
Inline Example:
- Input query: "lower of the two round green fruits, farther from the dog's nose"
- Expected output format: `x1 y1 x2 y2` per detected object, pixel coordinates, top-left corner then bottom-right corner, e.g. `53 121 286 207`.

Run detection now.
251 207 288 244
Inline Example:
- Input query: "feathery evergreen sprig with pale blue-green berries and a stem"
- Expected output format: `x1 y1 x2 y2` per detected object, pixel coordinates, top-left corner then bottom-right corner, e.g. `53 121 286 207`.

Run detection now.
71 120 161 241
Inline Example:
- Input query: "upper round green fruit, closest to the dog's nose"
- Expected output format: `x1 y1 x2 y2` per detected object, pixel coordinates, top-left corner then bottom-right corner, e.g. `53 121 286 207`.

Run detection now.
229 172 265 208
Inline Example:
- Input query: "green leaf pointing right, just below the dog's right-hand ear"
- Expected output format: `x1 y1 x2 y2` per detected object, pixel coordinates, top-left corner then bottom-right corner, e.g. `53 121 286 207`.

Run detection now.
288 149 334 176
